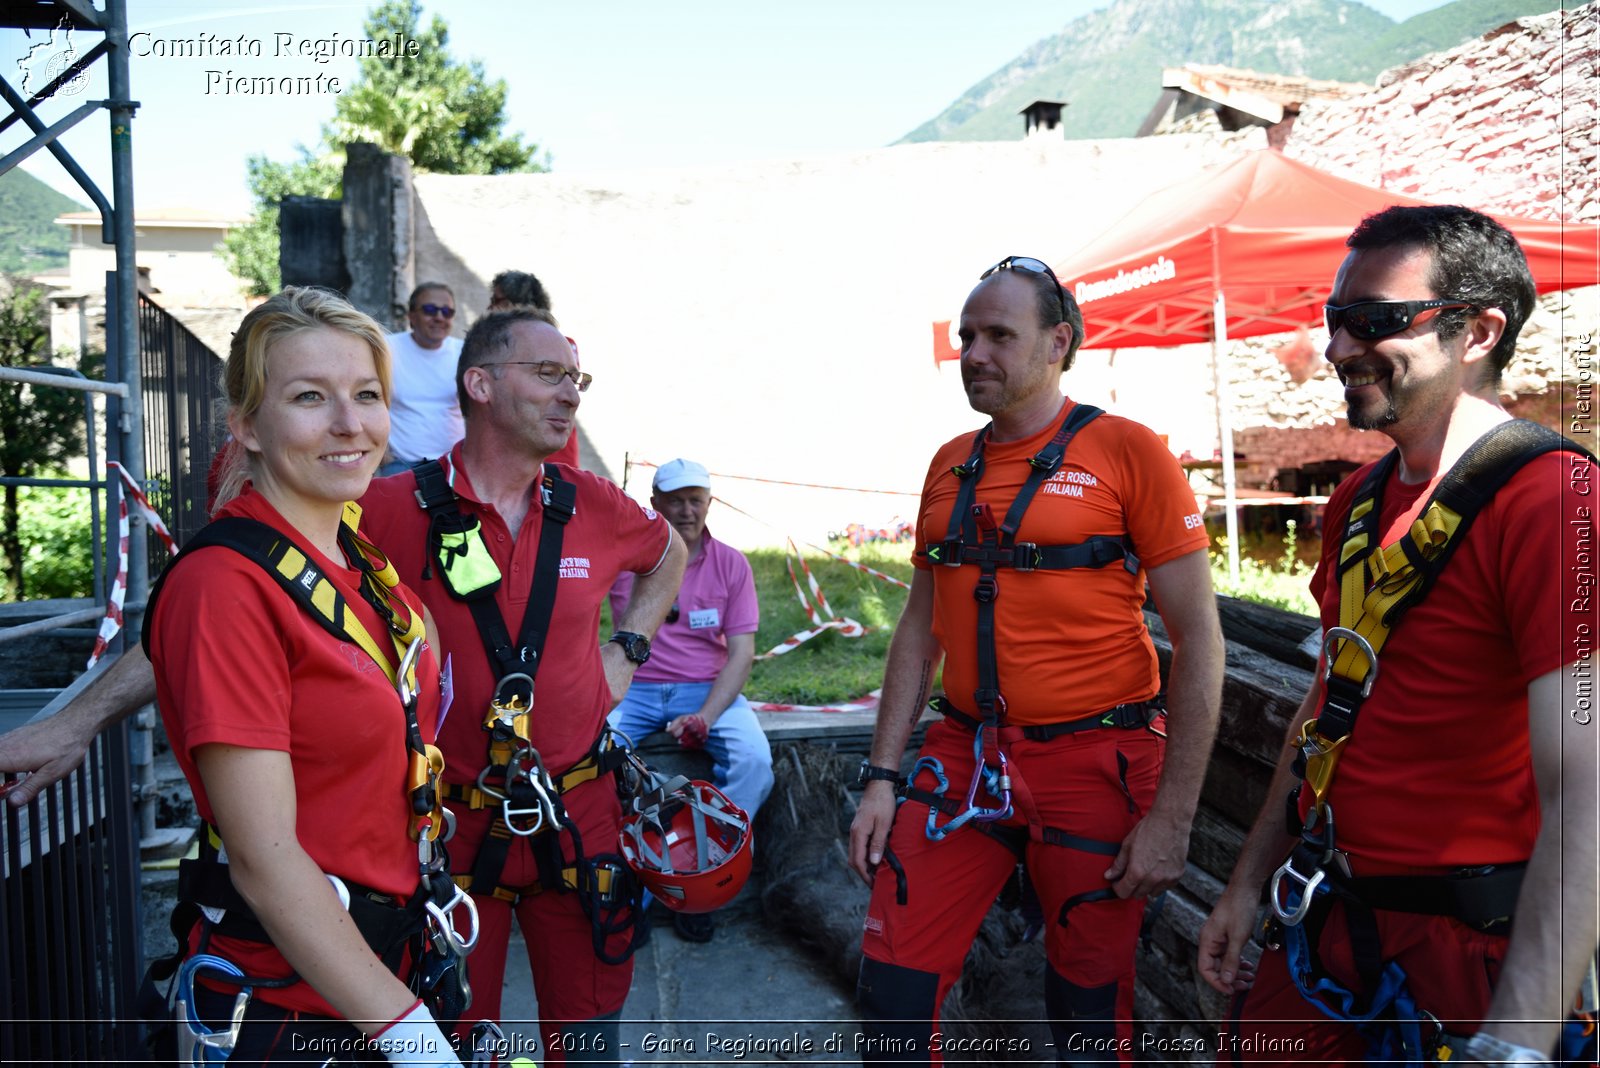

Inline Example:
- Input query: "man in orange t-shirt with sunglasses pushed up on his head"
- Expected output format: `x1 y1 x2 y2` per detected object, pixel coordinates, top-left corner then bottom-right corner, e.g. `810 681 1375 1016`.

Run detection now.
850 257 1222 1063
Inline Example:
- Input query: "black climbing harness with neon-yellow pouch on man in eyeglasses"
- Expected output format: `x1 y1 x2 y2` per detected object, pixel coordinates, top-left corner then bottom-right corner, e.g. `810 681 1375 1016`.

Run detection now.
413 460 640 964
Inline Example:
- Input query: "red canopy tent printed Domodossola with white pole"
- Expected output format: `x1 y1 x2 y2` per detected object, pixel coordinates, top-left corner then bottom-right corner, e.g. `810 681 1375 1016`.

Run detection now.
934 149 1600 571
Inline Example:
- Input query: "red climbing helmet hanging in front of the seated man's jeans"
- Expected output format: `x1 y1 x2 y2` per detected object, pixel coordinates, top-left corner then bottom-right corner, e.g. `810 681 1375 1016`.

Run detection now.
619 779 750 913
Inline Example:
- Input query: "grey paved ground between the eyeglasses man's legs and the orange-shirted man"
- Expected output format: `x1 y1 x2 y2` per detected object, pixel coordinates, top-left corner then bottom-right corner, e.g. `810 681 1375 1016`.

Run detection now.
502 891 861 1066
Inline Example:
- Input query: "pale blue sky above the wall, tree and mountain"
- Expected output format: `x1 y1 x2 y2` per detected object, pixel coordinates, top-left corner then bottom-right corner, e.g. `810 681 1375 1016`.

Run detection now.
0 0 1440 211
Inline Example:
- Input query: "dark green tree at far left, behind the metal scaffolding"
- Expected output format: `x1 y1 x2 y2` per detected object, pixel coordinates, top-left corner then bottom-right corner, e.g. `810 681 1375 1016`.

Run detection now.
0 280 83 600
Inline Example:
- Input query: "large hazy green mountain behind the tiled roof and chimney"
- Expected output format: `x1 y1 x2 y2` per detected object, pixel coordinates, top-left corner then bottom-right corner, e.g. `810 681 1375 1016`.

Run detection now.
901 0 1576 144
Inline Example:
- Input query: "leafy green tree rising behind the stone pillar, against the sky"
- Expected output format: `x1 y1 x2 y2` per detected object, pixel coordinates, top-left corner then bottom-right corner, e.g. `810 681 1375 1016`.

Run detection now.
222 0 547 296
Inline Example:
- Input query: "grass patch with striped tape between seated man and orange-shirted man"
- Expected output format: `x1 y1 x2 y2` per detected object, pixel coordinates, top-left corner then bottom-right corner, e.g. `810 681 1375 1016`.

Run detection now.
746 542 912 705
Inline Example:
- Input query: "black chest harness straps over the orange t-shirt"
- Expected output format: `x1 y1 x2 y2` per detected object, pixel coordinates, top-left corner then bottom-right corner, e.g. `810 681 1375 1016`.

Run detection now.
925 404 1139 726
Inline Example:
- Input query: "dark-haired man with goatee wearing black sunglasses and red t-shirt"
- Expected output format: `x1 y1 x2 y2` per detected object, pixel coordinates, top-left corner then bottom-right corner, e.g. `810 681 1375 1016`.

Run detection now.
1198 206 1597 1063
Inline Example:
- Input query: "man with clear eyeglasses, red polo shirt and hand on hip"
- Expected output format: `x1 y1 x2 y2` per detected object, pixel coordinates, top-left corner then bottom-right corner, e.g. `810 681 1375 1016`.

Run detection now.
360 307 685 1063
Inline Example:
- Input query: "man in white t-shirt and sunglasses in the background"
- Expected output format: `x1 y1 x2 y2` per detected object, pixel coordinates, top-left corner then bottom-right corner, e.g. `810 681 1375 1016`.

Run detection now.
378 281 462 476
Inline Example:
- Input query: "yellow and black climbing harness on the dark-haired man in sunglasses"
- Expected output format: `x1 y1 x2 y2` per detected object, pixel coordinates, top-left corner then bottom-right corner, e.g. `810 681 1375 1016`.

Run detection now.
1269 419 1594 1063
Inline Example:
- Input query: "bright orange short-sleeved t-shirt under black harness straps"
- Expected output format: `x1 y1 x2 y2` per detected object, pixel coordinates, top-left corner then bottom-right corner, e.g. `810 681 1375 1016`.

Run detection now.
914 400 1210 724
